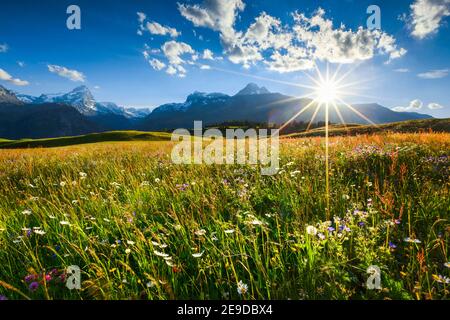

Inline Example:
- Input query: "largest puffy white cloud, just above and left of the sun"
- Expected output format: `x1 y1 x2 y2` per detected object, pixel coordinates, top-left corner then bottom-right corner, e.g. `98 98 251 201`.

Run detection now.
178 0 406 72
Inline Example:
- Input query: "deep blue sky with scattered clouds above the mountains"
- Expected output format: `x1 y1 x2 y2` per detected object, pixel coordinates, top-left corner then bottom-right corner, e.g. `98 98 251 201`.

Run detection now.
0 0 450 117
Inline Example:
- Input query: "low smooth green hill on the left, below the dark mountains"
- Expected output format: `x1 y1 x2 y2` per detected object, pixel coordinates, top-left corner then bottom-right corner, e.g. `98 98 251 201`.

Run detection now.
0 131 171 149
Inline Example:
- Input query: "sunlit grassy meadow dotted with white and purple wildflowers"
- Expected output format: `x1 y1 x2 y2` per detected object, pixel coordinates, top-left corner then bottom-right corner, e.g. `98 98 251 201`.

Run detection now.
0 133 450 300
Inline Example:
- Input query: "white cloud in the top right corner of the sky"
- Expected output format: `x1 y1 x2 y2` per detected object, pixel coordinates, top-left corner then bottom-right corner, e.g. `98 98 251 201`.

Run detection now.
409 0 450 39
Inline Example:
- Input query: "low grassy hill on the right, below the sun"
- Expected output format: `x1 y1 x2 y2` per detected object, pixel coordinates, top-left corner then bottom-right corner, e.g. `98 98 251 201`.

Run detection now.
286 118 450 138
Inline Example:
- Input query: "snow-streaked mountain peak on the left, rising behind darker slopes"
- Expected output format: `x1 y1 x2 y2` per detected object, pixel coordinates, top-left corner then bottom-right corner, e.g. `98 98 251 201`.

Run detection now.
16 86 150 119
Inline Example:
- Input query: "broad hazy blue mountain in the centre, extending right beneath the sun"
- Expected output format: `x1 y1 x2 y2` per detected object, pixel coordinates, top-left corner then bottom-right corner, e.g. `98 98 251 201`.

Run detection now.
139 83 430 131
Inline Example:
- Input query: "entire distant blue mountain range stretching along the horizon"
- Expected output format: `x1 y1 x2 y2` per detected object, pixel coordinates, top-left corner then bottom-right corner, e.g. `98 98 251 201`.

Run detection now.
0 83 431 139
